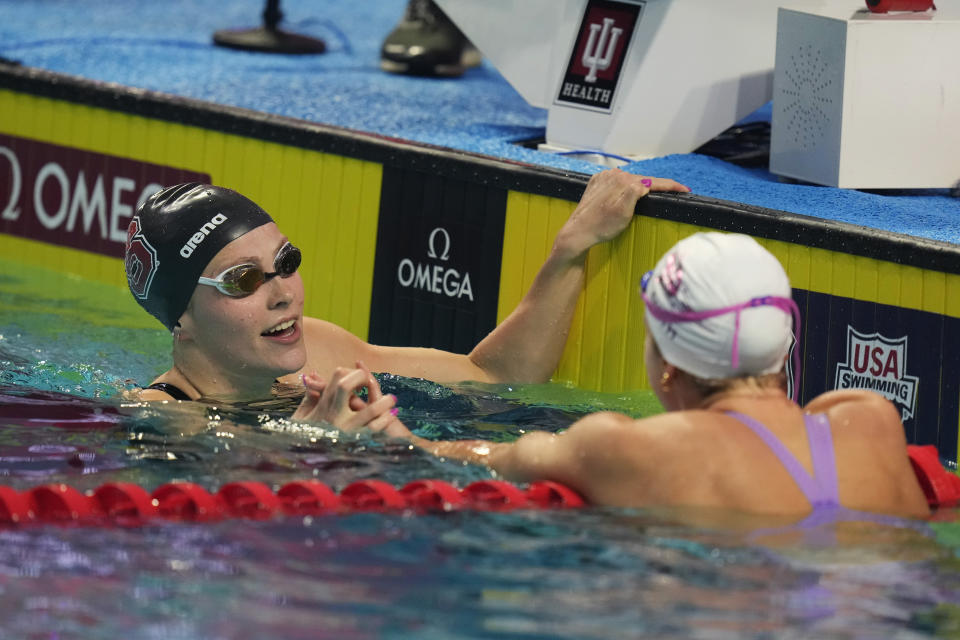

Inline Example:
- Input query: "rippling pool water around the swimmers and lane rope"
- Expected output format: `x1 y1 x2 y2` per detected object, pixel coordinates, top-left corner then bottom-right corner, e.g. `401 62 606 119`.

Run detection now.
0 260 960 639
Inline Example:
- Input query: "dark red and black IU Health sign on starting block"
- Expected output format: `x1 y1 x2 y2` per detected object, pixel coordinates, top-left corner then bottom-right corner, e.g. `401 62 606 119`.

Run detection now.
556 0 645 111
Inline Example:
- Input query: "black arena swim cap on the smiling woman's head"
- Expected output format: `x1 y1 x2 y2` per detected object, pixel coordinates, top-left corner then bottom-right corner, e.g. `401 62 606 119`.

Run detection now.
124 182 273 331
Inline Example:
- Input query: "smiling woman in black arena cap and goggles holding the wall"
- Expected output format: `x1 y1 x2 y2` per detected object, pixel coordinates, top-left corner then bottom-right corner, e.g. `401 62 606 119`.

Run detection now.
126 170 689 428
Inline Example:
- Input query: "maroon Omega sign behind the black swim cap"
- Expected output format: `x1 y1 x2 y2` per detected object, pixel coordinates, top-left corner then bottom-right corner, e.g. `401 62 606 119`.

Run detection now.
0 134 209 256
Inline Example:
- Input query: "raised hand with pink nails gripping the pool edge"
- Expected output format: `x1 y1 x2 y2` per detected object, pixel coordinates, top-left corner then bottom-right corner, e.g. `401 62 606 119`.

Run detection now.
554 169 690 259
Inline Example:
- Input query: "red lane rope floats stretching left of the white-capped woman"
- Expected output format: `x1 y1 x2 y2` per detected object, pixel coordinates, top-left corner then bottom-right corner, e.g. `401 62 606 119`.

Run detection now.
0 480 585 526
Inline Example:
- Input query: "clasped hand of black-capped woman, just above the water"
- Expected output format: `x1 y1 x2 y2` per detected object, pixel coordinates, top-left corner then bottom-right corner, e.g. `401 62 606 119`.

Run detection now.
293 362 406 432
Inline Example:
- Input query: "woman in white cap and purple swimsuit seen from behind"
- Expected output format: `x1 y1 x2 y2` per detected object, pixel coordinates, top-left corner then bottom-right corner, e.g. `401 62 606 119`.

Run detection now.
362 233 929 526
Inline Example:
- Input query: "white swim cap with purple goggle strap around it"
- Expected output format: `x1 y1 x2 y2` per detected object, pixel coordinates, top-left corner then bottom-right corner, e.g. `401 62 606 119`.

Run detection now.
643 232 799 380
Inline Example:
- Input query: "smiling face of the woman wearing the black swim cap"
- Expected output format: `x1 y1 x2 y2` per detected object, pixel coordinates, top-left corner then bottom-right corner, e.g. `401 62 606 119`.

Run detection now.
180 223 306 380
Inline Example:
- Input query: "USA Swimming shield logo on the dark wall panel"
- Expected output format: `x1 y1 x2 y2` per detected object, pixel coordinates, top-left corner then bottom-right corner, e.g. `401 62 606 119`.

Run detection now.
834 325 920 422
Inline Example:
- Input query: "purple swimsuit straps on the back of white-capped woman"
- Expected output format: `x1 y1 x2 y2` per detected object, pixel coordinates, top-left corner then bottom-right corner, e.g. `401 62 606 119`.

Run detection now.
726 411 840 507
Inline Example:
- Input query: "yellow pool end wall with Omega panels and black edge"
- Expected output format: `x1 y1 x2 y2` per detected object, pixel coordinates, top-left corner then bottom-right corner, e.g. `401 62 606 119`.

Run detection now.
0 66 960 460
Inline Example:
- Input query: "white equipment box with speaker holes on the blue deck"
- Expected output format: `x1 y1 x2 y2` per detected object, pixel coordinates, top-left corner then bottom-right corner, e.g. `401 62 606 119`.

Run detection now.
770 0 960 189
